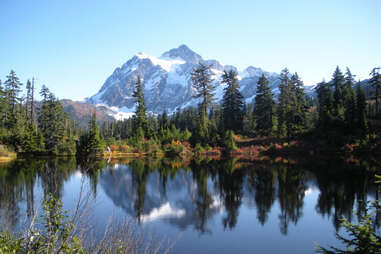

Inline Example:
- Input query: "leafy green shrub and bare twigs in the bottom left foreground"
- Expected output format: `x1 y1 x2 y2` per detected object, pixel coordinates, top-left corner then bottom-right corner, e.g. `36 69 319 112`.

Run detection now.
0 195 170 254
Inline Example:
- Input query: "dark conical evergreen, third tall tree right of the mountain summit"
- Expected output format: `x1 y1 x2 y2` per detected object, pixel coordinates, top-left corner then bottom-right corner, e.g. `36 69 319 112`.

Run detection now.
253 74 276 136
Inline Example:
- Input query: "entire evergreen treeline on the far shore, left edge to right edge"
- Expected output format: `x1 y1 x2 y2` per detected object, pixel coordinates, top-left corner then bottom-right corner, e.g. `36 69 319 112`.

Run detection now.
0 64 381 155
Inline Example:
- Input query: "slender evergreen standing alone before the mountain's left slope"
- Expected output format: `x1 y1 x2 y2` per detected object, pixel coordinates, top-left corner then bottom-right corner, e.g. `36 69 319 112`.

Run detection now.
133 76 148 135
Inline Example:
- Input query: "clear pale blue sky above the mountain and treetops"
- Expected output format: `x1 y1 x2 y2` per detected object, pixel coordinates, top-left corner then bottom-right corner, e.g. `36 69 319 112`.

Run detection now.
0 0 381 100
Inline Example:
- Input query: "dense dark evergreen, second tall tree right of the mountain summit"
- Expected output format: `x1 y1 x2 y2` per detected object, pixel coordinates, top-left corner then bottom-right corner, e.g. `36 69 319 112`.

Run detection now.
222 70 244 131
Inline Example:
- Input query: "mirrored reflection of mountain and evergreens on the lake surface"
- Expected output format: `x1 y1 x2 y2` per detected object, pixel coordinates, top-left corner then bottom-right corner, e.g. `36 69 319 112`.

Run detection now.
0 158 378 235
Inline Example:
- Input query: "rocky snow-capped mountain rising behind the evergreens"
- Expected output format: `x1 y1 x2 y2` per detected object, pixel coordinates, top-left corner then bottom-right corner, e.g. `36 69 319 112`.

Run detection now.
88 45 288 117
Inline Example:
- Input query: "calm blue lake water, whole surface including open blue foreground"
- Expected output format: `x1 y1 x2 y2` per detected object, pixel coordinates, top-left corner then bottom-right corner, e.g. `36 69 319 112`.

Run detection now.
0 158 380 253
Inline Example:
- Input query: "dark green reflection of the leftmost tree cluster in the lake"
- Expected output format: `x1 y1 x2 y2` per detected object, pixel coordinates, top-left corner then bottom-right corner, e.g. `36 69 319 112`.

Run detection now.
0 158 76 230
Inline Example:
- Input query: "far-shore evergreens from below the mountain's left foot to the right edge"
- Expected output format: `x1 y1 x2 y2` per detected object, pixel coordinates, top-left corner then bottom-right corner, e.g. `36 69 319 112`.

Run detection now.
100 64 381 147
